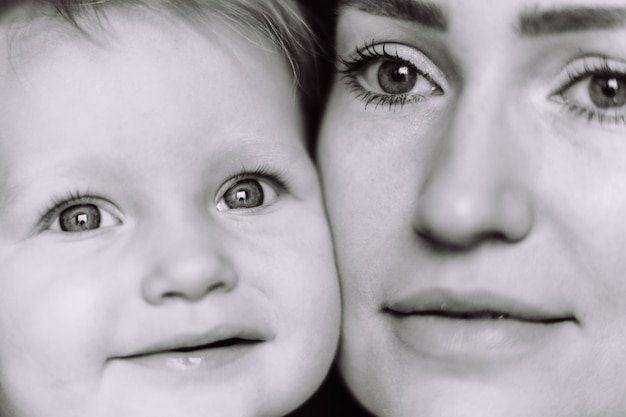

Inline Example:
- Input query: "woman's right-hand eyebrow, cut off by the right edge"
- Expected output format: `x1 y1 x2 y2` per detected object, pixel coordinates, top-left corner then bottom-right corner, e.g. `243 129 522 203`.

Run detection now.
518 7 626 36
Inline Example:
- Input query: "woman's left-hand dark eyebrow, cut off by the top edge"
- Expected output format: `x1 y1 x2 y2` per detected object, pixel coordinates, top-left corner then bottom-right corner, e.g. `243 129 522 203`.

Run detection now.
340 0 448 32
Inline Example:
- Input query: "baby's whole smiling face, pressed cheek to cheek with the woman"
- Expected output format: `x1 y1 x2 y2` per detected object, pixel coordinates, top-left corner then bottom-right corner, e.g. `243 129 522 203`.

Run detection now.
0 8 339 417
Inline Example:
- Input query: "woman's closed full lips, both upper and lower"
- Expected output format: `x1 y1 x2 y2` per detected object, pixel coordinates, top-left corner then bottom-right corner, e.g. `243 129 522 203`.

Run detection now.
383 289 579 360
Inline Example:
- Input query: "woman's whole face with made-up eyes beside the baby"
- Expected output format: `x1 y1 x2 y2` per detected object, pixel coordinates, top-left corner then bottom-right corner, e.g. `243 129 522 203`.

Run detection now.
318 0 626 417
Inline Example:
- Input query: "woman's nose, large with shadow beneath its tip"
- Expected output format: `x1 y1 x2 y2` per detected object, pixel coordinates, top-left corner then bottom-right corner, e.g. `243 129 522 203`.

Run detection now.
414 103 533 249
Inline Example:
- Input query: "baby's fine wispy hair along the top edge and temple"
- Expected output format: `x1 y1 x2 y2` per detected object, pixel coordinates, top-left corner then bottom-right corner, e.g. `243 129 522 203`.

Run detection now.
7 0 322 143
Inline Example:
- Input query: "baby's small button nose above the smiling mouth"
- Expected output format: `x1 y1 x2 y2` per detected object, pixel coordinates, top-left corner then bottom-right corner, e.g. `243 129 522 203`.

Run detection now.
142 219 238 305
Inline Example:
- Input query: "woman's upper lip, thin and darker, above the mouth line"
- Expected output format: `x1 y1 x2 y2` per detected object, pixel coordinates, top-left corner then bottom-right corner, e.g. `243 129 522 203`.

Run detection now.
383 289 578 323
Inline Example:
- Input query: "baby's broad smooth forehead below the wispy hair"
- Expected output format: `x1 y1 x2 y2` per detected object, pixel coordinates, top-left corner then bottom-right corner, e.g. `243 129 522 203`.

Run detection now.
0 8 300 171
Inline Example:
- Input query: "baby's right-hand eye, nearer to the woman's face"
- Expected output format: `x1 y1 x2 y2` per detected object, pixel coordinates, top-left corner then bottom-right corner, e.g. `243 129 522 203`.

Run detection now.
217 178 277 211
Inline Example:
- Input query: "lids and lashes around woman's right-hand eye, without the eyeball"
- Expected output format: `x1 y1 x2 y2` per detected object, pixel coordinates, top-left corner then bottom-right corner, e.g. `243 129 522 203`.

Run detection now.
551 57 626 125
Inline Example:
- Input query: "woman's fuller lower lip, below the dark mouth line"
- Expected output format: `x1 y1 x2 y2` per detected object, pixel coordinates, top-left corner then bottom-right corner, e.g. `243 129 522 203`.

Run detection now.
390 315 572 359
